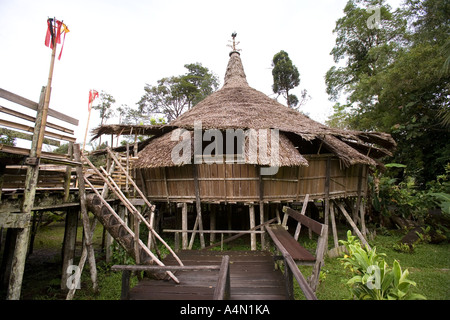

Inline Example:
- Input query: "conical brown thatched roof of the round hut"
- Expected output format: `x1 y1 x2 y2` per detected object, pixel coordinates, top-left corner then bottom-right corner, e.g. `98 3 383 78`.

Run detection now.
135 51 396 168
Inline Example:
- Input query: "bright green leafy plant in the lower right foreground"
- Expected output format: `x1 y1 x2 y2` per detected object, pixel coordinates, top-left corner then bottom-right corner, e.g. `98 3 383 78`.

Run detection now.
340 231 425 300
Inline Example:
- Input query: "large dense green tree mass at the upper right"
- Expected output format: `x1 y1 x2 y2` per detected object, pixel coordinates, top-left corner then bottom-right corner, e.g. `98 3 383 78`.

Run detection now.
326 0 450 187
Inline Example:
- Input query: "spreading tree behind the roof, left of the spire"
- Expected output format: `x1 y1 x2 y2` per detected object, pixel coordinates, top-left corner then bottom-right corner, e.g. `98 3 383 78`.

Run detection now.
137 63 219 122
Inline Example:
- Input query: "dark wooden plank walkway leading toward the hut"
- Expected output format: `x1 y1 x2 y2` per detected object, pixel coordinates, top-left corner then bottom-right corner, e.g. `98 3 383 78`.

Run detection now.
130 250 287 300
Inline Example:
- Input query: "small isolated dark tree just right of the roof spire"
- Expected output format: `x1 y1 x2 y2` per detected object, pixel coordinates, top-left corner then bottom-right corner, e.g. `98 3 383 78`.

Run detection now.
272 50 306 108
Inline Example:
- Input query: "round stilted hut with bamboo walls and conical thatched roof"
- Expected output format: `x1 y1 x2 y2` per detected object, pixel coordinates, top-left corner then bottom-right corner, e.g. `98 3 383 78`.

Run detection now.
128 45 396 250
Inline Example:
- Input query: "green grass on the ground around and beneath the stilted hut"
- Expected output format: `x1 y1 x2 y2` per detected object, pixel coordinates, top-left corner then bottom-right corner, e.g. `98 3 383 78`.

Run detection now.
2 218 450 300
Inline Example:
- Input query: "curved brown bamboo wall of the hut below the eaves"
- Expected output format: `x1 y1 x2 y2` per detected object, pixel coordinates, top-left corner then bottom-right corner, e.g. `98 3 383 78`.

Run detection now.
138 155 367 203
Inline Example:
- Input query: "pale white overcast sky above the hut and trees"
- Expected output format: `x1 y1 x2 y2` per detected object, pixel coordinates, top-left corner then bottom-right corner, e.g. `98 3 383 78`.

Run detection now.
0 0 398 151
